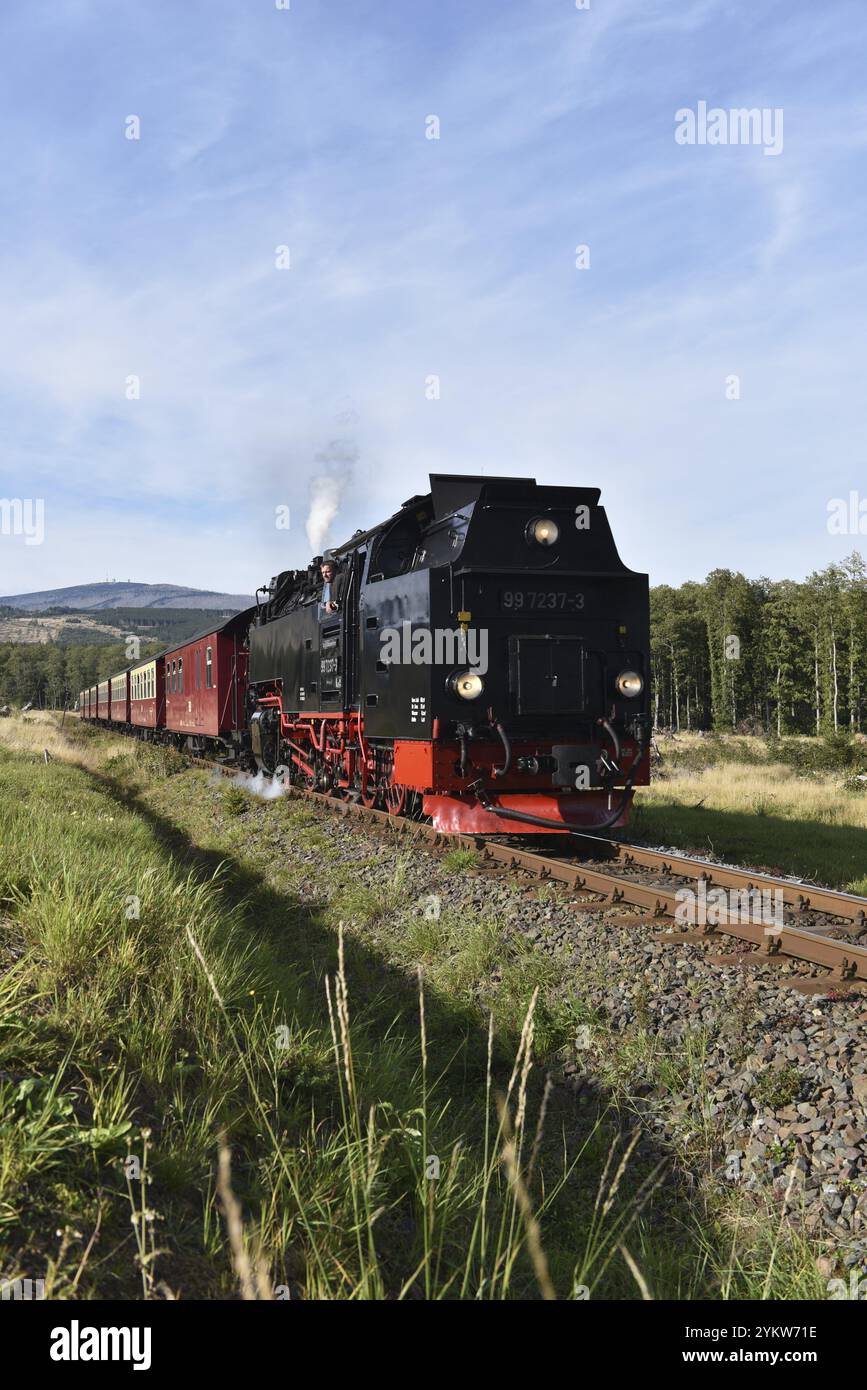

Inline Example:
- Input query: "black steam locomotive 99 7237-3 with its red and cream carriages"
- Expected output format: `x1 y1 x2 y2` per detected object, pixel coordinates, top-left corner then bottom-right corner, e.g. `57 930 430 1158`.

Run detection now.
81 474 650 834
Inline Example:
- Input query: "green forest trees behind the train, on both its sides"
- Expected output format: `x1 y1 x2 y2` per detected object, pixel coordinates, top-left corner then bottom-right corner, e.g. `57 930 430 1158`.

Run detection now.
0 552 867 737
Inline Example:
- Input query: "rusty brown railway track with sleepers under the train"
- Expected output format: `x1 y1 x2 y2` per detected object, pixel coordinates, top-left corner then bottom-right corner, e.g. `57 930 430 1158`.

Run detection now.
200 758 867 992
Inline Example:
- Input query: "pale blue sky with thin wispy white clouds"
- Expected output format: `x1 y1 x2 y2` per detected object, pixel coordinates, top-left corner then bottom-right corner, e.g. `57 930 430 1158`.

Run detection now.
0 0 867 594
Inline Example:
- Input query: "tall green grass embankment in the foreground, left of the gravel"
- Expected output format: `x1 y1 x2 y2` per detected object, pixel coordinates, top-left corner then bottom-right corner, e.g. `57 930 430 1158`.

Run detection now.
0 719 855 1300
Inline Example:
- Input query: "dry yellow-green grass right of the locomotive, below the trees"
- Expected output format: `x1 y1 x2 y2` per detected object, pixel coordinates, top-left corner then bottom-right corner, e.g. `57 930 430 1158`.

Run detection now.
632 734 867 894
